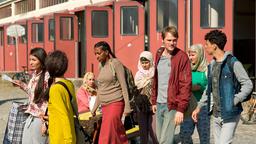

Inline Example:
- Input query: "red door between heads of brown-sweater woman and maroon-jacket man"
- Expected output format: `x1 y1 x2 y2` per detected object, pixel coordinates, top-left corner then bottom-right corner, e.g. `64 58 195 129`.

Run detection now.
113 1 145 73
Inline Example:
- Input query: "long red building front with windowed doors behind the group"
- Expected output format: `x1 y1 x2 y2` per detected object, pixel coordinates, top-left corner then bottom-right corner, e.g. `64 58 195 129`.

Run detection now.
0 0 255 77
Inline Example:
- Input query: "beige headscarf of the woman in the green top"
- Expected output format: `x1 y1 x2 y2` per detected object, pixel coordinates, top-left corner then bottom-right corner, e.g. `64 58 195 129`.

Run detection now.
188 44 208 72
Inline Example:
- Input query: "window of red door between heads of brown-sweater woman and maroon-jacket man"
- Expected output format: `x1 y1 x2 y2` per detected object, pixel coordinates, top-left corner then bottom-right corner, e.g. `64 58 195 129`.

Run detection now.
120 6 139 35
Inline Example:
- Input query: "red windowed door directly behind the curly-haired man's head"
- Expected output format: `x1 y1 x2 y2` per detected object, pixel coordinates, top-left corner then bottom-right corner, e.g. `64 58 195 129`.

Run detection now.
191 0 233 59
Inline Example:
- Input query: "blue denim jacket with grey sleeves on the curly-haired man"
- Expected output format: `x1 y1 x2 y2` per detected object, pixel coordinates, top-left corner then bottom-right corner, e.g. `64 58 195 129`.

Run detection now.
199 52 252 119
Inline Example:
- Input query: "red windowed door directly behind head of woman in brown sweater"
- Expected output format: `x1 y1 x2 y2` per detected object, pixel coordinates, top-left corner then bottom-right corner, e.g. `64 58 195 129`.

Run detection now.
85 6 113 74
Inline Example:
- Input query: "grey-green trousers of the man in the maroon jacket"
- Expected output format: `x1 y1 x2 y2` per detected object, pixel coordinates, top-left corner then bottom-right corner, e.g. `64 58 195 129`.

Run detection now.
156 103 176 144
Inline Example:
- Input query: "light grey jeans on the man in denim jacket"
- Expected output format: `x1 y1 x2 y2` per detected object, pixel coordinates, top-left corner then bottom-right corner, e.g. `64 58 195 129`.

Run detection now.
213 115 240 144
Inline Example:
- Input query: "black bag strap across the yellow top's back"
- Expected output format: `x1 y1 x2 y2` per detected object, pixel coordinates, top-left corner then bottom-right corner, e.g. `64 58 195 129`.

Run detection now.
55 81 91 142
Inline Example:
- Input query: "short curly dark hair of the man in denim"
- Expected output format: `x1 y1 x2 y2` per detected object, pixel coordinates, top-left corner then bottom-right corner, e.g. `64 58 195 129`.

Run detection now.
204 30 227 50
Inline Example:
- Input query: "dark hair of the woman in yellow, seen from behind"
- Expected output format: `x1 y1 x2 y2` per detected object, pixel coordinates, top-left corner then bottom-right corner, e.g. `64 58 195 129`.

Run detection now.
45 50 68 99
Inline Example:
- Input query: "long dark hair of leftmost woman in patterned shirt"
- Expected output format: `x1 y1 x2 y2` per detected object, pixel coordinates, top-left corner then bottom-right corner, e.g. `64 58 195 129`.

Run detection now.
30 47 47 103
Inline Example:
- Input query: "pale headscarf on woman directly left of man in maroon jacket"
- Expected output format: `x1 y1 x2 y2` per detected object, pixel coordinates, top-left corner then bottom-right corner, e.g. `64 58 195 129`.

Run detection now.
134 51 154 89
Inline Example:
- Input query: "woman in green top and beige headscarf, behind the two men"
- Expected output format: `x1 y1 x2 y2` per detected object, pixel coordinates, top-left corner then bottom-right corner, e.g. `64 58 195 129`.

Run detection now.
180 44 210 144
